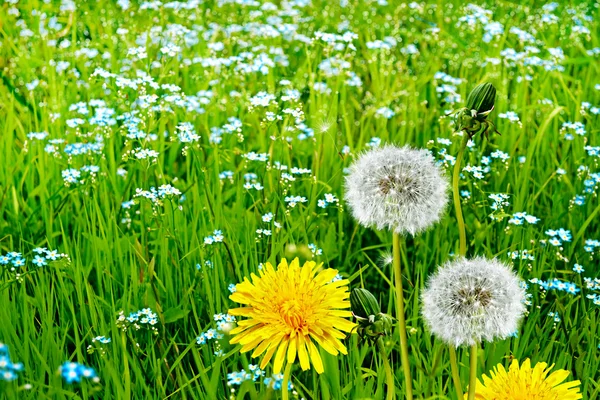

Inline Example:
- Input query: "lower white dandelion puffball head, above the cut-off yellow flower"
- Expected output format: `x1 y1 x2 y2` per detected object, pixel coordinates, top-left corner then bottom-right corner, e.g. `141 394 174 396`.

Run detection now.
422 257 525 347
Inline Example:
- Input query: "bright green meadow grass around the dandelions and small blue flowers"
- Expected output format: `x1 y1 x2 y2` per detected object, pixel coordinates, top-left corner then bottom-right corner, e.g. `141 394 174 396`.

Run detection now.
0 0 600 400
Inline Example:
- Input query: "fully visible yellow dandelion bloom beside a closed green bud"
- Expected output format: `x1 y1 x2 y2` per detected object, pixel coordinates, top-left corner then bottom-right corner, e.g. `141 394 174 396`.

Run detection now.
229 258 355 374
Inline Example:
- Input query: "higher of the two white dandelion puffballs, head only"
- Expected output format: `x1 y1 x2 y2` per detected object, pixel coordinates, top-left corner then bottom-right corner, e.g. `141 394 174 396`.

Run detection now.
344 145 448 235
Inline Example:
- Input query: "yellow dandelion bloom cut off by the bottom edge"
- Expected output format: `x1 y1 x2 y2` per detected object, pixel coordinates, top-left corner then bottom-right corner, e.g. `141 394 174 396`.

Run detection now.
475 358 583 400
